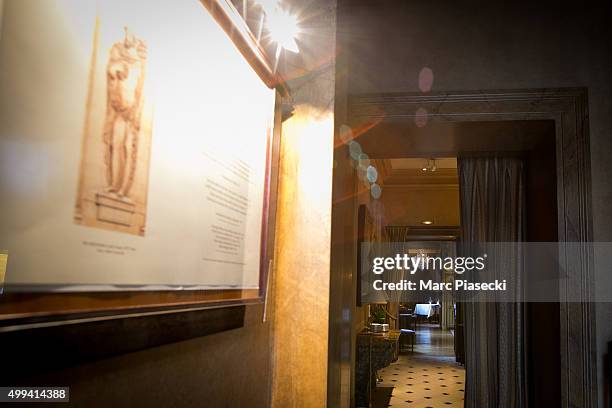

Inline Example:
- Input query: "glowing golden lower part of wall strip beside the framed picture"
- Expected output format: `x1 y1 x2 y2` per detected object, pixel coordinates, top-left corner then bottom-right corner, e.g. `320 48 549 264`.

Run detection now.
272 105 334 407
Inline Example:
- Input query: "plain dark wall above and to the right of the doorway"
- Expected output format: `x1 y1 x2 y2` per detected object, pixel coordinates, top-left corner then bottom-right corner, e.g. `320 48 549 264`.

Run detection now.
339 0 612 405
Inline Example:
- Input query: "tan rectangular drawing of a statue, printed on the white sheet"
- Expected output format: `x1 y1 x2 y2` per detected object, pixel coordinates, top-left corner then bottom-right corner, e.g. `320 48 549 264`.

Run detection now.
74 27 153 235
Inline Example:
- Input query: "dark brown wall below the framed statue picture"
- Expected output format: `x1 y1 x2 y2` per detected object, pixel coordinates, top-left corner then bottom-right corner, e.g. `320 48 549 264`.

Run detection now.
16 305 271 408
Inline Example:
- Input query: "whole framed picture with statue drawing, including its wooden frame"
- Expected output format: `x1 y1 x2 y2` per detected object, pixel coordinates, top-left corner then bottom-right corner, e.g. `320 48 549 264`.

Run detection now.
0 0 278 326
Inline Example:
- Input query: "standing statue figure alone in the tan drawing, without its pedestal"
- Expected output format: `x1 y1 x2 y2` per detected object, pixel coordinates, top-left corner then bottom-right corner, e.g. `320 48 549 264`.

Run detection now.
103 27 147 201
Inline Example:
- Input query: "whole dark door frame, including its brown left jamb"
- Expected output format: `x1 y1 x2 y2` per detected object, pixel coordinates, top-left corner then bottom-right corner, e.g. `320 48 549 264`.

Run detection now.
328 88 597 407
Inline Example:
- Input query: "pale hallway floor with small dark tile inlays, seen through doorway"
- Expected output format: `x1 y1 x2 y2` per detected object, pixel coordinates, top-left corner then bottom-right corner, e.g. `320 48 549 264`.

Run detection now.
373 324 465 408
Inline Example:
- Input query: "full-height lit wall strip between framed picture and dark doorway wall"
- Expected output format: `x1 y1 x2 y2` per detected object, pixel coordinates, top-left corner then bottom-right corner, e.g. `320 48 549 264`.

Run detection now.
272 0 336 408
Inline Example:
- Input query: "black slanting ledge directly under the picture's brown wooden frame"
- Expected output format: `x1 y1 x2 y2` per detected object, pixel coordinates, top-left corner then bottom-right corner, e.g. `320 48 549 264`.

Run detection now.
0 305 246 385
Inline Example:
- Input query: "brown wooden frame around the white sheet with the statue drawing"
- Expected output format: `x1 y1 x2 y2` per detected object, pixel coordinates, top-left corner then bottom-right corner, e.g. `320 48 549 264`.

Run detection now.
0 0 282 332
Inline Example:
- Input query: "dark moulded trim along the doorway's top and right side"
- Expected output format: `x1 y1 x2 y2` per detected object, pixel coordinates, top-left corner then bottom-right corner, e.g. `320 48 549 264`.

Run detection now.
340 88 597 407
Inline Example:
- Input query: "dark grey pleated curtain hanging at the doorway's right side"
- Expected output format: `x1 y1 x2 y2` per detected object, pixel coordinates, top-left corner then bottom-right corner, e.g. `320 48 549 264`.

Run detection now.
458 158 526 408
